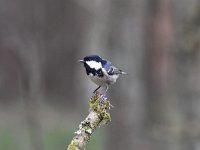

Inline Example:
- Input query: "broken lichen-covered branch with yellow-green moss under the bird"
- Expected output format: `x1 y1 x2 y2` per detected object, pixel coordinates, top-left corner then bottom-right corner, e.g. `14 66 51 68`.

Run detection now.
67 94 112 150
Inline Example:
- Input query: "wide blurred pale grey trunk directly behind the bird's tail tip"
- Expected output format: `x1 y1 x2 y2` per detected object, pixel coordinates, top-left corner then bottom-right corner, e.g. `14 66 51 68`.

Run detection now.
106 0 148 150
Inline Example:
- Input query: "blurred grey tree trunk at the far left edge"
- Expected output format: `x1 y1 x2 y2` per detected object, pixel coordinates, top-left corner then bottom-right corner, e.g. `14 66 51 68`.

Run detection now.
1 1 43 150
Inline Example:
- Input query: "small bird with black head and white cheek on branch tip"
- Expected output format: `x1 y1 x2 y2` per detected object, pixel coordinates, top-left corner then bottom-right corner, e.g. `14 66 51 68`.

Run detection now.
79 55 127 96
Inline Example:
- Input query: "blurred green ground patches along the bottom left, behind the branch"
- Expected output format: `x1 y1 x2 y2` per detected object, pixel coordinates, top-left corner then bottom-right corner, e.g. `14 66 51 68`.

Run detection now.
0 127 103 150
